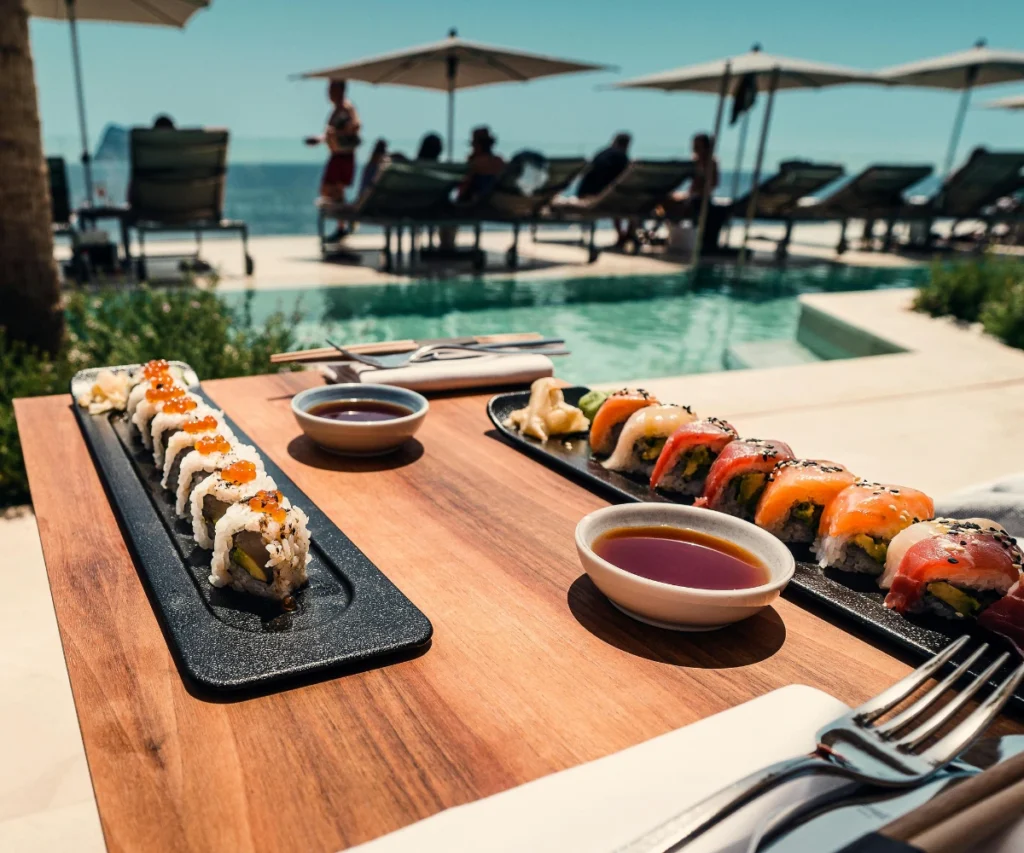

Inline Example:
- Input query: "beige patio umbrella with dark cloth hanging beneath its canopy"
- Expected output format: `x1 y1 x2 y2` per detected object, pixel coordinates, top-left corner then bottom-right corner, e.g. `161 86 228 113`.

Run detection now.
614 45 879 265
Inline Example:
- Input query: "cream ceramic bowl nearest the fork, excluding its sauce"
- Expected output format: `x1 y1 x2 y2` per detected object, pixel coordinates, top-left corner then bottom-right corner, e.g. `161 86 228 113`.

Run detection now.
575 504 797 631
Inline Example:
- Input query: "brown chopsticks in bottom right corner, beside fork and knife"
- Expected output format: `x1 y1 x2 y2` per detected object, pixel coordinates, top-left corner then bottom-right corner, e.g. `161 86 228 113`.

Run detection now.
841 754 1024 853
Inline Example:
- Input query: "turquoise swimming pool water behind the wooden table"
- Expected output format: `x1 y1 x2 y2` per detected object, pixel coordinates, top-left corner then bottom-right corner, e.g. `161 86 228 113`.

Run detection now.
225 265 927 383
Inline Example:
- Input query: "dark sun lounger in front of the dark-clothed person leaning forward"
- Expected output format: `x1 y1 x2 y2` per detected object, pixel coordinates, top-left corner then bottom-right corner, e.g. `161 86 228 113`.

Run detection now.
545 160 694 263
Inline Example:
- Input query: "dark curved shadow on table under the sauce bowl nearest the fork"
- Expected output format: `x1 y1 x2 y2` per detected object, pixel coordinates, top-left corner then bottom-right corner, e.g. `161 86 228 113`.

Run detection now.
567 574 785 670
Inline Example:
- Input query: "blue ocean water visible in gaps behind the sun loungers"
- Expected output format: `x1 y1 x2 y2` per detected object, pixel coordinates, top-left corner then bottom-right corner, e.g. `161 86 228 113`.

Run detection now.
59 162 946 236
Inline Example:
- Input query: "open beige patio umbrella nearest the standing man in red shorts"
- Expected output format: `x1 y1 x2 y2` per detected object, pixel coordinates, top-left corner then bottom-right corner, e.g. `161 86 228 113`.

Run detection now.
299 30 613 160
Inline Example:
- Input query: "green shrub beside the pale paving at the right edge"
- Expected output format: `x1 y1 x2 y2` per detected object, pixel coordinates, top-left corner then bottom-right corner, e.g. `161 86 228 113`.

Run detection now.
913 257 1024 323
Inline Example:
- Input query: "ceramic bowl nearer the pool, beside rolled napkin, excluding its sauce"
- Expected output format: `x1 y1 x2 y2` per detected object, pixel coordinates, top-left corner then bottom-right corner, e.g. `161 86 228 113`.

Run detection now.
292 382 430 456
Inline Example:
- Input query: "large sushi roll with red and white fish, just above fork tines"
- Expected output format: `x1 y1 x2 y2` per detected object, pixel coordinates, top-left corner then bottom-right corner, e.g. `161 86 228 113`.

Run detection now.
886 521 1021 619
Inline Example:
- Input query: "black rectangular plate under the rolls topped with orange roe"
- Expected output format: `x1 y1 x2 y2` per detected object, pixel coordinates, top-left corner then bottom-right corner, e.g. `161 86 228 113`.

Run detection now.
74 387 433 692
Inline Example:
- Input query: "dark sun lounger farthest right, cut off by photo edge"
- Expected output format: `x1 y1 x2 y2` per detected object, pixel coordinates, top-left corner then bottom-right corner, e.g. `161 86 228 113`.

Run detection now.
900 148 1024 246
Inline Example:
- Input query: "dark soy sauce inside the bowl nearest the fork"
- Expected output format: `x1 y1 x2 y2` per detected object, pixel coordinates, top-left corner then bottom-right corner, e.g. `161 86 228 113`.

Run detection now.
591 524 771 590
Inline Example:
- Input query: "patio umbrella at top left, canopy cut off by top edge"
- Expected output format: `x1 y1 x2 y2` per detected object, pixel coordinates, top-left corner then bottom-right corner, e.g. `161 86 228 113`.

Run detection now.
24 0 212 205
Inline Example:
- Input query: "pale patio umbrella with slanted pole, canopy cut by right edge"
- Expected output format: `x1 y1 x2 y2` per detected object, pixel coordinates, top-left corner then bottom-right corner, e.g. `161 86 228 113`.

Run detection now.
879 39 1024 175
